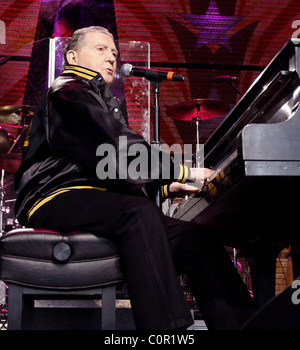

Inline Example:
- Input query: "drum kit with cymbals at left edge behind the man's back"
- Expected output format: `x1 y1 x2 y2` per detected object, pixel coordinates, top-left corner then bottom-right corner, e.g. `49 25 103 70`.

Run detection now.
0 106 34 236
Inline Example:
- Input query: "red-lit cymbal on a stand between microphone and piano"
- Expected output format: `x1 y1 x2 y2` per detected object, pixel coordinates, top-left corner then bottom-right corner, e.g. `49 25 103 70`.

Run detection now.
166 98 230 121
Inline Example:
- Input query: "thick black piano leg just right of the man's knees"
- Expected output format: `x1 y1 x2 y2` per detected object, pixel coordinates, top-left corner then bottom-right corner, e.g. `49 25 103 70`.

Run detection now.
248 246 283 308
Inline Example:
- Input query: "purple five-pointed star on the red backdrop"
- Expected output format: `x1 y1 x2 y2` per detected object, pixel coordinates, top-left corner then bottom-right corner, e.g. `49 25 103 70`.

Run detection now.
182 0 244 51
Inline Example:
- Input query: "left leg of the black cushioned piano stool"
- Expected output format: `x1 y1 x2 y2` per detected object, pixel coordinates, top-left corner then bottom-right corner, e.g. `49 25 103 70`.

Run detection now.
7 284 23 330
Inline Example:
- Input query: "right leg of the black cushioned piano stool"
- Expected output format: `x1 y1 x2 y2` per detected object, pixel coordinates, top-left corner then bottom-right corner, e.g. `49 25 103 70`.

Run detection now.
101 285 116 330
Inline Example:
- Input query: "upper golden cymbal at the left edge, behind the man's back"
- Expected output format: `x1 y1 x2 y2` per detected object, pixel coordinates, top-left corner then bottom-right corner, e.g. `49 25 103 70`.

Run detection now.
0 105 35 126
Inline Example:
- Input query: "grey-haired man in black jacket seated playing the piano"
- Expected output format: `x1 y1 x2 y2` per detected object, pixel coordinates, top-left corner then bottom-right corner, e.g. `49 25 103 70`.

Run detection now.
15 27 254 330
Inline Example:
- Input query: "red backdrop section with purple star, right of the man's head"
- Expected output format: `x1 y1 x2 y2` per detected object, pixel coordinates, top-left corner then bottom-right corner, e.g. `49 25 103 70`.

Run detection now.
114 0 300 144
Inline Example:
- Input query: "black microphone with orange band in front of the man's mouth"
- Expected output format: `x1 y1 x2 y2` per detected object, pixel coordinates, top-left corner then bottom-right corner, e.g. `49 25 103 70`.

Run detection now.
121 63 184 81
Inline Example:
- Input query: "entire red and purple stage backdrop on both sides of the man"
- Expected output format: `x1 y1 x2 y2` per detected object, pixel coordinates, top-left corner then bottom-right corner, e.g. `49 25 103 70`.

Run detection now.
0 0 300 144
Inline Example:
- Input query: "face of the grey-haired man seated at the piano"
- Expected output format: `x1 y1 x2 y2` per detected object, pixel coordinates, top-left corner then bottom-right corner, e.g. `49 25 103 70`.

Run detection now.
67 32 118 86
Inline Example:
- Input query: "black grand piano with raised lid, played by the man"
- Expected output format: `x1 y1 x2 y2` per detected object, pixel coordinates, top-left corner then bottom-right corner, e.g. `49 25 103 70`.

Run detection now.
173 39 300 305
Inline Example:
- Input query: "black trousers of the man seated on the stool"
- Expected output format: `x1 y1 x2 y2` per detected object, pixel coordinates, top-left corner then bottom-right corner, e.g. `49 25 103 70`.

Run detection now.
30 189 255 330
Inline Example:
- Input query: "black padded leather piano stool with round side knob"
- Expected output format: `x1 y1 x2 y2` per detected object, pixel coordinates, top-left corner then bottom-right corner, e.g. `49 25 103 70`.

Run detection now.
0 228 123 329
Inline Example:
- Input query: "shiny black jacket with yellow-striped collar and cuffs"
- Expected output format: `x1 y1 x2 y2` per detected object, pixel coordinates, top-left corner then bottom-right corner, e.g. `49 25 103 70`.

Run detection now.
15 66 189 226
